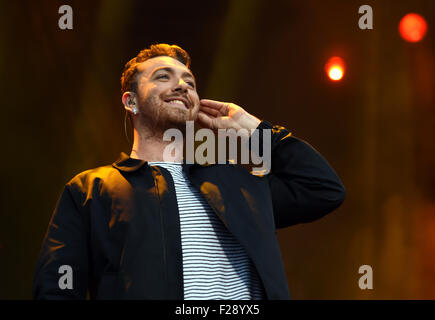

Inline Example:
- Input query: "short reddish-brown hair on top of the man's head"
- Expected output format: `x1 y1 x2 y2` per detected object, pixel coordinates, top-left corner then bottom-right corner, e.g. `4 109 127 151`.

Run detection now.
121 43 190 93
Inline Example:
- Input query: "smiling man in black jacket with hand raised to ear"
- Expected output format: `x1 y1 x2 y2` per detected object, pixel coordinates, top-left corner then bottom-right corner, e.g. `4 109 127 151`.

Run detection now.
33 44 345 299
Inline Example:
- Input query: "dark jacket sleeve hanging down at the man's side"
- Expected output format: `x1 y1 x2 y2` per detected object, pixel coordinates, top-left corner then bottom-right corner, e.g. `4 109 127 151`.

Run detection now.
32 184 88 300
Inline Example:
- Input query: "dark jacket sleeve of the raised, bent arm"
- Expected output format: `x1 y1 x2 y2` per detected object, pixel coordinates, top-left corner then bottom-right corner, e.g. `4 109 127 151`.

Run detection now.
258 121 346 229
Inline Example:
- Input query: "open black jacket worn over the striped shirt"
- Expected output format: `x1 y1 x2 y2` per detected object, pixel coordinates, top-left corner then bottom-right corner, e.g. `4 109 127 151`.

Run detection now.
33 121 345 300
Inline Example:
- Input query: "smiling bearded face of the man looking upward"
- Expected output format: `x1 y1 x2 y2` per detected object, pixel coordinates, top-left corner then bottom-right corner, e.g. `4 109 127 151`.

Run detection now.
137 56 200 130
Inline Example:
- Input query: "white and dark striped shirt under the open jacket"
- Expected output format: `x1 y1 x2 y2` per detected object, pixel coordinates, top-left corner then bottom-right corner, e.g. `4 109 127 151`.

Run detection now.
148 161 264 300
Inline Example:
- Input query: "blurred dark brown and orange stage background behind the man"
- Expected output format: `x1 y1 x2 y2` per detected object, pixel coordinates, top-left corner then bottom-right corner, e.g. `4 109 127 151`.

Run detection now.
0 0 435 299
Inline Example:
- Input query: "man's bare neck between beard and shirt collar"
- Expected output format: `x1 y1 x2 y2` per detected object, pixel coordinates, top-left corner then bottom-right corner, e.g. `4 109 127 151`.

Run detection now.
130 125 184 162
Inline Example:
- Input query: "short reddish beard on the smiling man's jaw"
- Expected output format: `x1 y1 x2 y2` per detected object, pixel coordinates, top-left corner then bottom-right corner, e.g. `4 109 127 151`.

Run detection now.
139 95 197 135
